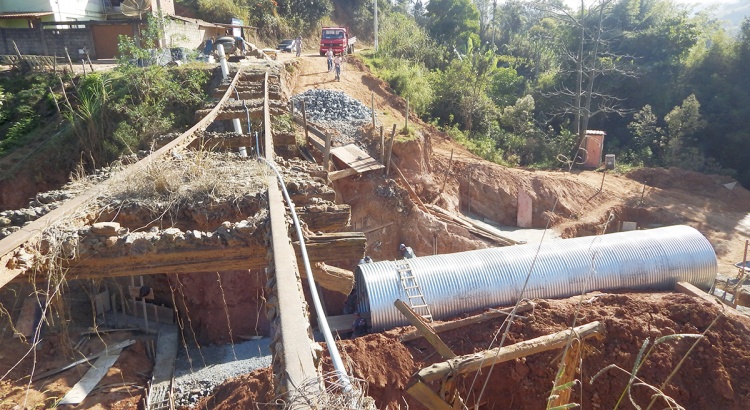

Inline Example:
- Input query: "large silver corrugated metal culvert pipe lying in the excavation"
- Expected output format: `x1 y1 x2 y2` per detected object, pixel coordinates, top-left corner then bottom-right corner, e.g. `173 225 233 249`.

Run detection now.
355 225 717 331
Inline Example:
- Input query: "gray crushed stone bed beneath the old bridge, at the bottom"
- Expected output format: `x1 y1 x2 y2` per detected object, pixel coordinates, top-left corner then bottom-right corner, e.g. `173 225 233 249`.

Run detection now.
174 338 271 408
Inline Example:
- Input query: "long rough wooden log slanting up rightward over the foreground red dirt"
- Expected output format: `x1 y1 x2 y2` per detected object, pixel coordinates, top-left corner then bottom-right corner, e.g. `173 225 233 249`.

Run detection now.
417 322 604 382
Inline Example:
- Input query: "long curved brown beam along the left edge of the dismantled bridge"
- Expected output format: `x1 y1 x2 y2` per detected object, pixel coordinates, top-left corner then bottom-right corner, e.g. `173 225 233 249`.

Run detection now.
0 70 242 288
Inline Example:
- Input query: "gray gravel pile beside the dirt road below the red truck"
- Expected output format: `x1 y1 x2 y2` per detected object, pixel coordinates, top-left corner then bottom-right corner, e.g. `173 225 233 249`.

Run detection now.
292 89 372 146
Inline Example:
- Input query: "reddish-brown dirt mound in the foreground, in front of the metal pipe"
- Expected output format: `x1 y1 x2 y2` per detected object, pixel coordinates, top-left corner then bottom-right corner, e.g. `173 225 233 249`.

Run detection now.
200 293 750 409
